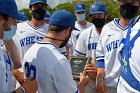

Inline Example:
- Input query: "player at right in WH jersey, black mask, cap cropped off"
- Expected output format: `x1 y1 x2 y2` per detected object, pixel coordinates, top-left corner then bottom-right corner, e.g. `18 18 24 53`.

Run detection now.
96 0 139 93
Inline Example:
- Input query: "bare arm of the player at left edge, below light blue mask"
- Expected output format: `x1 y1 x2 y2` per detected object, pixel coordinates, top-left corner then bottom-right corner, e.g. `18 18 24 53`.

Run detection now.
3 39 21 69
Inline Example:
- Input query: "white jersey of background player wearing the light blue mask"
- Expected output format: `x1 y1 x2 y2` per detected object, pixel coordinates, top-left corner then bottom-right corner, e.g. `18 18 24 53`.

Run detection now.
67 22 93 56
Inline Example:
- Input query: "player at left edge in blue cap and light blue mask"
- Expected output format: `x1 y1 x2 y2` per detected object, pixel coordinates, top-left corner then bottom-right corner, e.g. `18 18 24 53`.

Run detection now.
0 0 37 93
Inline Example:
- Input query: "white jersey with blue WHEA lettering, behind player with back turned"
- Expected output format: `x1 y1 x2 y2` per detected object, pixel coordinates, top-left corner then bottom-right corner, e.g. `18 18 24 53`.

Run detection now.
13 21 66 61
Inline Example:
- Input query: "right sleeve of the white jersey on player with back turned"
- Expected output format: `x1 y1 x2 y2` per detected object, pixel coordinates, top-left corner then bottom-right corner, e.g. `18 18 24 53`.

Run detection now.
53 59 78 93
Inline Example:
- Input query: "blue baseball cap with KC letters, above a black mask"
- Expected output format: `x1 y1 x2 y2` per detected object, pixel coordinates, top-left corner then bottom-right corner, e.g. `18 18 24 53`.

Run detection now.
89 2 107 14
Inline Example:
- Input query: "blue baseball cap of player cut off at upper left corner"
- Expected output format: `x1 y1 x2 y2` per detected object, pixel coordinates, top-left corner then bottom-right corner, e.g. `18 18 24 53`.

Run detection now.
0 0 24 20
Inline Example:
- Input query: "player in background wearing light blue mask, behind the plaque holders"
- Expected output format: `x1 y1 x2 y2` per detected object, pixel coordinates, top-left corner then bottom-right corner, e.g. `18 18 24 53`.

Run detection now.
67 2 93 56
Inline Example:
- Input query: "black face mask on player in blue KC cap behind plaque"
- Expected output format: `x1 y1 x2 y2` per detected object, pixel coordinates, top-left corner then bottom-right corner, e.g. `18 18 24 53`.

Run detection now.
91 18 105 28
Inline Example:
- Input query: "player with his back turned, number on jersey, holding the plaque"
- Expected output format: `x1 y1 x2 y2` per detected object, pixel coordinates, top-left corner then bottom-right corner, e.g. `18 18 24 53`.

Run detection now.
23 10 87 93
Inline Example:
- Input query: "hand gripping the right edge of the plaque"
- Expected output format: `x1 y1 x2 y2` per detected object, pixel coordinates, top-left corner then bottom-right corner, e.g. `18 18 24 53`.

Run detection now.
84 64 97 79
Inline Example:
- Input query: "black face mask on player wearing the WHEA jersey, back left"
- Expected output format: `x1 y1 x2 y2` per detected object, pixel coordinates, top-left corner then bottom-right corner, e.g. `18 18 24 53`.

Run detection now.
32 7 46 20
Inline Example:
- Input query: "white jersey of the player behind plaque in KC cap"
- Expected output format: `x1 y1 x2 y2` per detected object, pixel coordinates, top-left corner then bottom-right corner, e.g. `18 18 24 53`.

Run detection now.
74 26 99 59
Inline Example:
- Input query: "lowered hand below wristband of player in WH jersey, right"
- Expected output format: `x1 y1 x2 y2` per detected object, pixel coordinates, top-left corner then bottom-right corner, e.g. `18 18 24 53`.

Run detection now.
96 81 107 93
